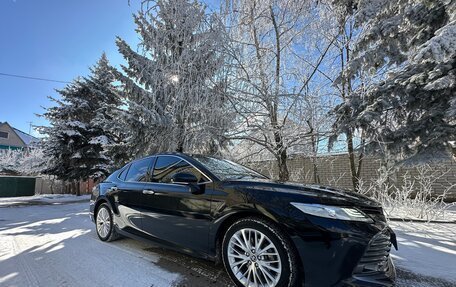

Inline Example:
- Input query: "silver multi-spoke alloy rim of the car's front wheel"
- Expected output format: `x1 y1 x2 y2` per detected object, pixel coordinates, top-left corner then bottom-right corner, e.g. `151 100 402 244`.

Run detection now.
227 228 282 287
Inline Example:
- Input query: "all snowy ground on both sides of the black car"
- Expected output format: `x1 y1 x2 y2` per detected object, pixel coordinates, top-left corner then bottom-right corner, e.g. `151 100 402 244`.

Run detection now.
0 202 456 287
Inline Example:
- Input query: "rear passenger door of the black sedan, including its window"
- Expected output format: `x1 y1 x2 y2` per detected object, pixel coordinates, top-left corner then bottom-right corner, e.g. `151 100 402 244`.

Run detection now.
116 157 154 232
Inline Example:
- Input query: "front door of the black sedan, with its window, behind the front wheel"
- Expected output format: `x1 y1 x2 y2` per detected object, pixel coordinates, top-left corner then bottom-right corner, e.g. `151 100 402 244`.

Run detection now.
143 155 215 253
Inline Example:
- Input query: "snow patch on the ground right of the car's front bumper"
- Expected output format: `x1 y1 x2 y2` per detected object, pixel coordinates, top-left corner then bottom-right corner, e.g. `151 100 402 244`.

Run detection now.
390 222 456 284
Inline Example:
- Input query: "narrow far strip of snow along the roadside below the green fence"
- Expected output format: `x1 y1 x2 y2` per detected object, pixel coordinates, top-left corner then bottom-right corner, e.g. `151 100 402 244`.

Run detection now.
0 194 90 207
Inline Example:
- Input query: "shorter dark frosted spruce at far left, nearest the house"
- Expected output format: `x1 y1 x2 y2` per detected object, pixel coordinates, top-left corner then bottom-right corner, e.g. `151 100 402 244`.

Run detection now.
39 79 110 187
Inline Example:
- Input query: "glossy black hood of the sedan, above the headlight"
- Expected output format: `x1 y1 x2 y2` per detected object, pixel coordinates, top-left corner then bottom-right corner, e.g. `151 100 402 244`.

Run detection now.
231 179 381 207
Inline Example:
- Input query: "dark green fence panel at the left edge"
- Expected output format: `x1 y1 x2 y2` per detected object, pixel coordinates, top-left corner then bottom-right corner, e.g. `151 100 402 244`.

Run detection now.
0 176 36 197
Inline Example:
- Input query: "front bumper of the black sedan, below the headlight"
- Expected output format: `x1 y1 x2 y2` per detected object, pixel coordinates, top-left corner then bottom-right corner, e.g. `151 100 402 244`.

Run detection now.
290 217 396 287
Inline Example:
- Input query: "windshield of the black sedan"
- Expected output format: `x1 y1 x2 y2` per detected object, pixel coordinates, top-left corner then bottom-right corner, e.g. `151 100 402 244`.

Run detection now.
193 156 267 180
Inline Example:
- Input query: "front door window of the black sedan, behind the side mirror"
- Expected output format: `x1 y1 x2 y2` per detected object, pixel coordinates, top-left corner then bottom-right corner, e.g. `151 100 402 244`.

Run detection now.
152 156 208 183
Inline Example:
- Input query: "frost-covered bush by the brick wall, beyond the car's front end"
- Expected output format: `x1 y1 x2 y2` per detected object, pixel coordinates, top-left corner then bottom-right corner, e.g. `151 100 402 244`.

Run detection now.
359 165 456 222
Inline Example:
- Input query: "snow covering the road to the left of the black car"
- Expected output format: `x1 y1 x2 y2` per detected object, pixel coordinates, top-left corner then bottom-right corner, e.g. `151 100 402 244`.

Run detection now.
0 203 179 287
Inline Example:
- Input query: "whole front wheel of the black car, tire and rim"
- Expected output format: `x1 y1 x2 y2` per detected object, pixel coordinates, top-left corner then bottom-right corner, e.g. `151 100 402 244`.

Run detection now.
222 217 299 287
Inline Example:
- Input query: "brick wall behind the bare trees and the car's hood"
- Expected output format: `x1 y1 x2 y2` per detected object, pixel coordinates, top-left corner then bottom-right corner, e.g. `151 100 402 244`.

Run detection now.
246 154 456 201
